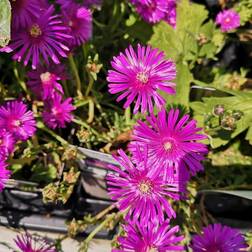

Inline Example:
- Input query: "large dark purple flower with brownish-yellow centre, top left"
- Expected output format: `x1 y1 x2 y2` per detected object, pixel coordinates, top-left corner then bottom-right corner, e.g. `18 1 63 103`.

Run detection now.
0 6 72 69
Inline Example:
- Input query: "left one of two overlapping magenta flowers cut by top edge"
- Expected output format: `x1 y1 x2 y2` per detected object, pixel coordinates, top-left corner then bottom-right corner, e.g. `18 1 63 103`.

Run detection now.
131 0 168 23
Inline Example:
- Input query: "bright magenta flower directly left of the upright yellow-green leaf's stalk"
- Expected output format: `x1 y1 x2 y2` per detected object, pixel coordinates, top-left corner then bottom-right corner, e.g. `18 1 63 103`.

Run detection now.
107 45 176 113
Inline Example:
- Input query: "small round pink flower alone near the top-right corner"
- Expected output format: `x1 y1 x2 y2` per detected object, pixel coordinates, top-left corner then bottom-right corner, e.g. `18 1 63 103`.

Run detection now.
215 9 240 32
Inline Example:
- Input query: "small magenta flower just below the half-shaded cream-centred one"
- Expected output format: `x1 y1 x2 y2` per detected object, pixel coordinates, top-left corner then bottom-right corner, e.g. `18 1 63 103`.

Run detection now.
43 94 75 129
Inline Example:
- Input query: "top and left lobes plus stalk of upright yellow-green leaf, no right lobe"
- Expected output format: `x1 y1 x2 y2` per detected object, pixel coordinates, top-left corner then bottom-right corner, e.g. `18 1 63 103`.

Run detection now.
149 0 208 106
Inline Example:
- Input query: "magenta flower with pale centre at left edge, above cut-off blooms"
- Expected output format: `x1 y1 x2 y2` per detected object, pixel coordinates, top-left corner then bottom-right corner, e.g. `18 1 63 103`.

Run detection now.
0 101 36 141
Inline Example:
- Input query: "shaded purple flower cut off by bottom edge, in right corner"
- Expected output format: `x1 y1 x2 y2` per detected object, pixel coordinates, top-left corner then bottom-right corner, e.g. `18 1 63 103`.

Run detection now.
191 224 247 252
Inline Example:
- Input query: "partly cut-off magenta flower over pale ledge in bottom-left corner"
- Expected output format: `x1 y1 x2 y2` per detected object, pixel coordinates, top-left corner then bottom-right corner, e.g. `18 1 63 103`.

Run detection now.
14 232 57 252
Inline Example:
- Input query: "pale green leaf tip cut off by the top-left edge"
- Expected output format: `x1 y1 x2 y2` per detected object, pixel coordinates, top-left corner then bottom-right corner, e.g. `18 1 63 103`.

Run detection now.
0 0 11 47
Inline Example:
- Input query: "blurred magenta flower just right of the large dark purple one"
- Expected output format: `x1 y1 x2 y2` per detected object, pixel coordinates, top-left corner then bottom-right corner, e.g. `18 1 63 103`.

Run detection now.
63 4 92 46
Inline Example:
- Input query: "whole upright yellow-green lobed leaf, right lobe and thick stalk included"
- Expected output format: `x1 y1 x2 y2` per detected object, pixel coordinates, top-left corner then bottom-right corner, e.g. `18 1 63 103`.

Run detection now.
149 0 224 106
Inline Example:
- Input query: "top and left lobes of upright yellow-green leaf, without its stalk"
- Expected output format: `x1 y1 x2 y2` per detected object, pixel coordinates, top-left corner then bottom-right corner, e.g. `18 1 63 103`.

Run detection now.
150 0 208 61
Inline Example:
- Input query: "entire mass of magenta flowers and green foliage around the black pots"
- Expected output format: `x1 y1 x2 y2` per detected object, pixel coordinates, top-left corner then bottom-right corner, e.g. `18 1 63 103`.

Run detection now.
0 0 252 252
